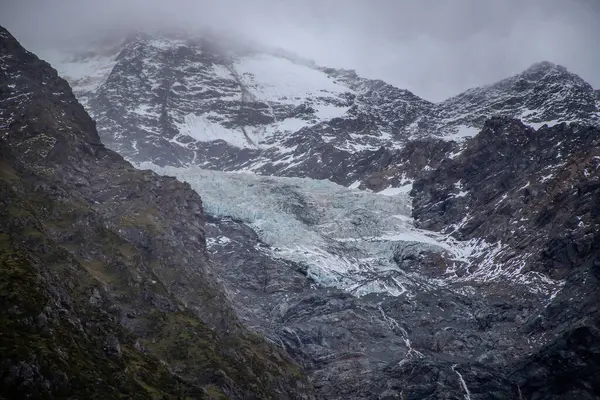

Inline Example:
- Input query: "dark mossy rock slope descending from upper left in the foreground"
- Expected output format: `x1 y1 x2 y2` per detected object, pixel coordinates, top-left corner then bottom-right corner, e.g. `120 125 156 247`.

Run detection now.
0 28 313 399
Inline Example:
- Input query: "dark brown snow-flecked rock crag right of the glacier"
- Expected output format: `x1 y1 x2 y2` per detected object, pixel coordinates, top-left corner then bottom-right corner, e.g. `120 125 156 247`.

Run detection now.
414 118 600 279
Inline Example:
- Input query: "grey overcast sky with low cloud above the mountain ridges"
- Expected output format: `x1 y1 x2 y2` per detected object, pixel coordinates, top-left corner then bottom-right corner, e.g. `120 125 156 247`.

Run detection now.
0 0 600 101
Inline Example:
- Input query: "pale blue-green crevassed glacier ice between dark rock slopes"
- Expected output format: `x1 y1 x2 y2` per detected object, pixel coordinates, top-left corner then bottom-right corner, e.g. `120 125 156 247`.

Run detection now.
138 163 482 296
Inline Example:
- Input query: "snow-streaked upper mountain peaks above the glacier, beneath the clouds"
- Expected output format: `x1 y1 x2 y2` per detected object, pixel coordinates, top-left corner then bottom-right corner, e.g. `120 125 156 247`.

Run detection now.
43 35 600 187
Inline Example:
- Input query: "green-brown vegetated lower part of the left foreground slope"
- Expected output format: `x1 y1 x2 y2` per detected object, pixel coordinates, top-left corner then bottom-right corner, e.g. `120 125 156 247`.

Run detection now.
0 154 304 399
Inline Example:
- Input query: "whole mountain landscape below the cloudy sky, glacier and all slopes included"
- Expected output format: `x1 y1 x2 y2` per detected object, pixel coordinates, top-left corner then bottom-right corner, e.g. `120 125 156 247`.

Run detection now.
0 25 600 400
